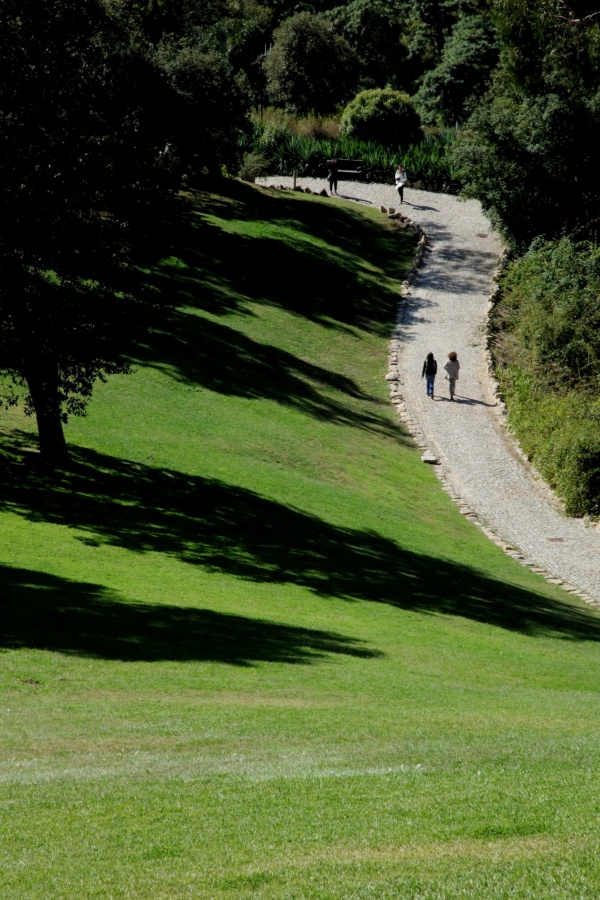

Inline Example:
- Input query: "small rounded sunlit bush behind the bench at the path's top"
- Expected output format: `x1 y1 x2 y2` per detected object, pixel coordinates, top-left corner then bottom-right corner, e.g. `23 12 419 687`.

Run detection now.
341 88 420 147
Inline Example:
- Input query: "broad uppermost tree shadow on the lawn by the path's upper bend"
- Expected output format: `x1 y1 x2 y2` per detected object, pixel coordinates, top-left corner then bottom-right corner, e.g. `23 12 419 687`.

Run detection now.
137 180 415 337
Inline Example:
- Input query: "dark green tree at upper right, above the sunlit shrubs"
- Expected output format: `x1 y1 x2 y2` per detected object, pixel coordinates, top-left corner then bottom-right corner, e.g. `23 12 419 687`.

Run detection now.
455 0 600 251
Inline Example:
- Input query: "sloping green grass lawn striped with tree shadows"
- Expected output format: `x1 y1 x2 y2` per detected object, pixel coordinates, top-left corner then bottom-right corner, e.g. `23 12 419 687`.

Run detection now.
0 183 600 898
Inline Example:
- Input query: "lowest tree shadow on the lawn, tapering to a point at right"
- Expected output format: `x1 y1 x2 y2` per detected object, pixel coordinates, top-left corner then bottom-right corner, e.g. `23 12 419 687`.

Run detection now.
0 566 381 666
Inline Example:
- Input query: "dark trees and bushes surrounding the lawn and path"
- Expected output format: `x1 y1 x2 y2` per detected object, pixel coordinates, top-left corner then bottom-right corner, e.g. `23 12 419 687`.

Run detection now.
0 0 600 515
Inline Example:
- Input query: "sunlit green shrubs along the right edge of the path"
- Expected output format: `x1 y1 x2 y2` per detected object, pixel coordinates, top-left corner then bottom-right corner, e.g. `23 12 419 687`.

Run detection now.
493 239 600 515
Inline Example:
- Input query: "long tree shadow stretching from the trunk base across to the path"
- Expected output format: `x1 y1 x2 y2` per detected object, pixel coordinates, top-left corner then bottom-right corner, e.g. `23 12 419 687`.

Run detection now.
0 438 600 640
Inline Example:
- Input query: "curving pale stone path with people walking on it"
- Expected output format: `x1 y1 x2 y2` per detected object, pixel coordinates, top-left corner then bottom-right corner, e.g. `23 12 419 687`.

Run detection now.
261 178 600 601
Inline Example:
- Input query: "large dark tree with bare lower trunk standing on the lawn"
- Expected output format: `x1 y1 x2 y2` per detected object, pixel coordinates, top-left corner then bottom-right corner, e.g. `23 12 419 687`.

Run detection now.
0 0 164 460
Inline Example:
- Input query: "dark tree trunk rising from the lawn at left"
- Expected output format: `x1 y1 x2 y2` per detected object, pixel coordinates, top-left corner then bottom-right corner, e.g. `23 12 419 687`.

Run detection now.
24 353 68 465
